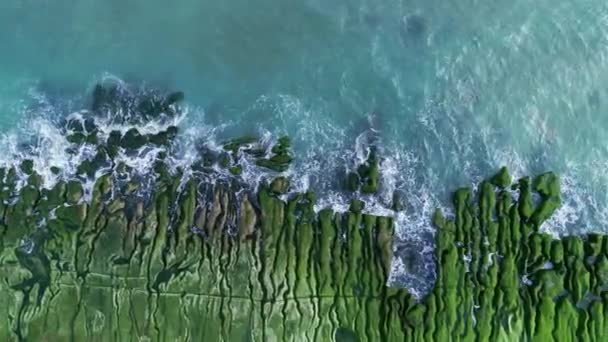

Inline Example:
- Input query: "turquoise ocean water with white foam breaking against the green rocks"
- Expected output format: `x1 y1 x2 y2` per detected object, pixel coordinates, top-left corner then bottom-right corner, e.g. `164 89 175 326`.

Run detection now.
0 0 608 293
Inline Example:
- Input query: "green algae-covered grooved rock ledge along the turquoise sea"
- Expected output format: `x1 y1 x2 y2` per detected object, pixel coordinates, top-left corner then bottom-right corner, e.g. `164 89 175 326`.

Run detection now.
0 86 608 342
